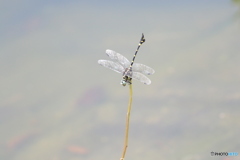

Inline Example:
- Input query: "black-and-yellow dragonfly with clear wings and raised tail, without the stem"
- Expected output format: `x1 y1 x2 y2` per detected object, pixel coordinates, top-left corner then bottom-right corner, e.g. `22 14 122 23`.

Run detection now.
98 34 155 86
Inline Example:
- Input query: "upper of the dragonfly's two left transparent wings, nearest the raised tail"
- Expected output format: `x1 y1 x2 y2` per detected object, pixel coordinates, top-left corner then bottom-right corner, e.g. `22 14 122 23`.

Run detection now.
106 49 130 68
